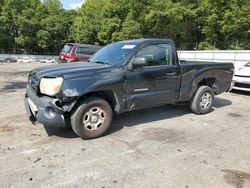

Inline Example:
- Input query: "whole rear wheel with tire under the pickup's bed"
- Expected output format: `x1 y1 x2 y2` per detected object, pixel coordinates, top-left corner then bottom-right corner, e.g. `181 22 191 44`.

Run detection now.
191 86 214 114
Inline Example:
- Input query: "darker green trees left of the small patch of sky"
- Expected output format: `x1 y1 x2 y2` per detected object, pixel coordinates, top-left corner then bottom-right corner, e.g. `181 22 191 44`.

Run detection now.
0 0 76 54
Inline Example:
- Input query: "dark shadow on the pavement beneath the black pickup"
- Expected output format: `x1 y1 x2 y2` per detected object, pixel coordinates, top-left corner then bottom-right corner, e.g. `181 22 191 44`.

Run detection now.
45 97 232 138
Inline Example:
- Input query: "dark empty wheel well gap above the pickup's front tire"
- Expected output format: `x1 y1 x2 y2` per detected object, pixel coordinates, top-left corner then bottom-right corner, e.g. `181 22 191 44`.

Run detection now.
78 90 119 112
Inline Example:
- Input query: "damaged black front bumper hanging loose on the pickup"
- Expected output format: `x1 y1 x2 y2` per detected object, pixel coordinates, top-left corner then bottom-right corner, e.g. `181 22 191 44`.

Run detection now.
24 85 66 127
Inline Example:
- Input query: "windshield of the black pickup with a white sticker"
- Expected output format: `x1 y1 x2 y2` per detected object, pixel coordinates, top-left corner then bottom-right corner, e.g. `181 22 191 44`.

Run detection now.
90 43 136 66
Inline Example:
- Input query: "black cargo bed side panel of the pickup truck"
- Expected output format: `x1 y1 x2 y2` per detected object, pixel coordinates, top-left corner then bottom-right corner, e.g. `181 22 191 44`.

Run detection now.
179 60 234 101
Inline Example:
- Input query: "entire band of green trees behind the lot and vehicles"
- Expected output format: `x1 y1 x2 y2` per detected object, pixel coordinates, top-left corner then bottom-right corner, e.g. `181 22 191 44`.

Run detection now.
0 0 250 54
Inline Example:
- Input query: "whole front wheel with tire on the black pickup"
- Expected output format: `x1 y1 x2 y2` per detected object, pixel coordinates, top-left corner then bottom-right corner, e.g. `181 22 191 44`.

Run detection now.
71 97 113 139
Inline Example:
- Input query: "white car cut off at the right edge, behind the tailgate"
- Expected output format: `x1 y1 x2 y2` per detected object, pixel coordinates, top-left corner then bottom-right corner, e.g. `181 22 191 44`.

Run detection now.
232 62 250 92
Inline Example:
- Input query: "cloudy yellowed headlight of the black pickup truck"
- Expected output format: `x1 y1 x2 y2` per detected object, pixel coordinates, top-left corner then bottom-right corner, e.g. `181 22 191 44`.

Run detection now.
40 77 63 96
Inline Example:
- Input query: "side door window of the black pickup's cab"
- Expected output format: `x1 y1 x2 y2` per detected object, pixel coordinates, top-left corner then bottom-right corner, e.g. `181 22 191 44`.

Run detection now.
136 44 172 66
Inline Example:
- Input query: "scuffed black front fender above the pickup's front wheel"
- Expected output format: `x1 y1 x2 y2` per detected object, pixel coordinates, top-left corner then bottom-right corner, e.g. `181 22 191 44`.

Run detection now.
59 68 126 113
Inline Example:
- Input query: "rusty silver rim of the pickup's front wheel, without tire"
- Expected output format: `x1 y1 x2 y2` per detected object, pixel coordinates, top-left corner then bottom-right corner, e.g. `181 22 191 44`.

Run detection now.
82 106 105 131
